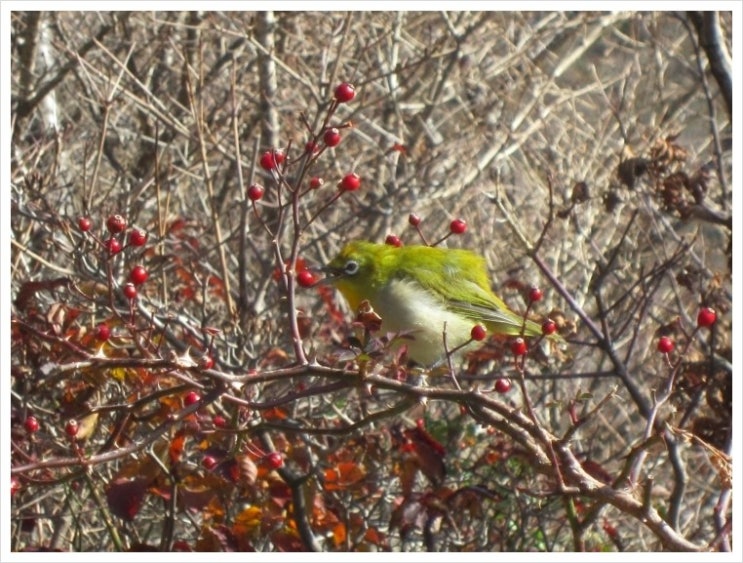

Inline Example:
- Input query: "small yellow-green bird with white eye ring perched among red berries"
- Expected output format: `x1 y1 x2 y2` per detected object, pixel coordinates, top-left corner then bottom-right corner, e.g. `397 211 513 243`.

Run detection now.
323 240 542 366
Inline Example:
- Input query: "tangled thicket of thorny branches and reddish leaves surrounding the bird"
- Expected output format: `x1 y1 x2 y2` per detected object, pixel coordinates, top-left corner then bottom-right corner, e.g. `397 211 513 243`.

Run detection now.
6 12 732 551
